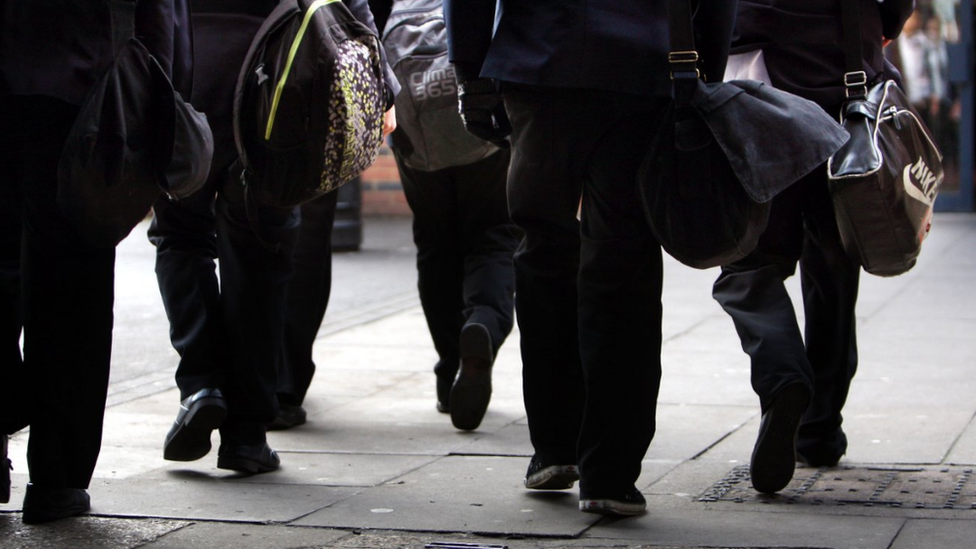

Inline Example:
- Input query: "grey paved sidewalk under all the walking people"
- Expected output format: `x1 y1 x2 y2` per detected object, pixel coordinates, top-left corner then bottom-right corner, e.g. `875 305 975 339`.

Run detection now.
0 214 976 549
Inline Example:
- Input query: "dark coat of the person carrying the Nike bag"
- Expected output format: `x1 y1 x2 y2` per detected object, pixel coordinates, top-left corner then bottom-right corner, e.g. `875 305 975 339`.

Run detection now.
732 0 914 112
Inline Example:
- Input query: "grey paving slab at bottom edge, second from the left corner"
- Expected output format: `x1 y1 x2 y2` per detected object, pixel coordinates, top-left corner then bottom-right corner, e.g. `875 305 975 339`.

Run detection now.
142 522 350 549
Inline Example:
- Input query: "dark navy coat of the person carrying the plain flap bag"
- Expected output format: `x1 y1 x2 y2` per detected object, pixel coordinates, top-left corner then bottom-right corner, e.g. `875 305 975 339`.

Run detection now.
445 0 735 95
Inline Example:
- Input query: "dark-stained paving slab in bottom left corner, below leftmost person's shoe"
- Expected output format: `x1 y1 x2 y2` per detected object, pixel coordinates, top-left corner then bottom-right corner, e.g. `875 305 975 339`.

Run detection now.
0 513 189 549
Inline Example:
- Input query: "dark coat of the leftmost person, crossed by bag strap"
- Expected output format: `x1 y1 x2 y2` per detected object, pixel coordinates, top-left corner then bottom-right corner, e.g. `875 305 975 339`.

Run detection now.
0 0 193 104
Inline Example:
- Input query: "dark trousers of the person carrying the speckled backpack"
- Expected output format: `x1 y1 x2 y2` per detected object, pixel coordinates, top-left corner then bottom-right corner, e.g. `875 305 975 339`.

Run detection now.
149 152 299 444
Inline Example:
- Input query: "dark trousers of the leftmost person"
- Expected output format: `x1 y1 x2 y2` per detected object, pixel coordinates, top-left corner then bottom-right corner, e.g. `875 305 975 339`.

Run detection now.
0 96 115 488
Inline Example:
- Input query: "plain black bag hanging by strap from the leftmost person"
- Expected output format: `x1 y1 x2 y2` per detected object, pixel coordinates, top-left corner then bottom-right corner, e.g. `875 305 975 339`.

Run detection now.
57 0 213 247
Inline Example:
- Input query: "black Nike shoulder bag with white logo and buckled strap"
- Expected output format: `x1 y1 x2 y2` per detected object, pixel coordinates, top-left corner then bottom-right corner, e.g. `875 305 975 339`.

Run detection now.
827 0 945 276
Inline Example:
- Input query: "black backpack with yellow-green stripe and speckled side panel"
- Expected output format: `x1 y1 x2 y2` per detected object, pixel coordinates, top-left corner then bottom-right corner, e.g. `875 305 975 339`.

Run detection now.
234 0 385 208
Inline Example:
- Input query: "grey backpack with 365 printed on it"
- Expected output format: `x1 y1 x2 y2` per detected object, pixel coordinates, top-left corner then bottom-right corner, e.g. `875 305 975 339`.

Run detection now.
383 0 498 171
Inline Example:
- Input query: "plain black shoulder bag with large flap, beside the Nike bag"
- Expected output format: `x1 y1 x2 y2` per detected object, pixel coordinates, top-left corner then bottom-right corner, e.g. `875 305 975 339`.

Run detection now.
638 0 848 269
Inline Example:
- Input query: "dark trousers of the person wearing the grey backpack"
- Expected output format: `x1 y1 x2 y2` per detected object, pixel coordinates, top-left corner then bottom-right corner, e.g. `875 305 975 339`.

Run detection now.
394 150 521 378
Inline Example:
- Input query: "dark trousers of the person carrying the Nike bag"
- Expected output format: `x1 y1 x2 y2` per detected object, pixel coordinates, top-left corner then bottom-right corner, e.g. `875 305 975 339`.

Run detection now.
712 166 860 455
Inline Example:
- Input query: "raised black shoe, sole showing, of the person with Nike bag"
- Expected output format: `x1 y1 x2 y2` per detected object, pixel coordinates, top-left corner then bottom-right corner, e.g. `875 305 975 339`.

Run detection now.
749 383 810 494
